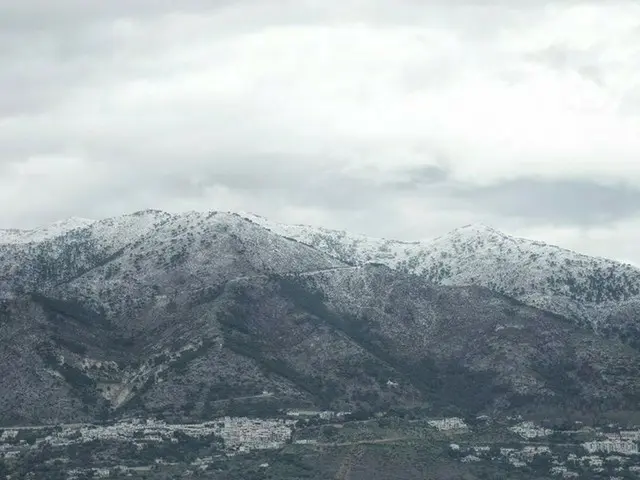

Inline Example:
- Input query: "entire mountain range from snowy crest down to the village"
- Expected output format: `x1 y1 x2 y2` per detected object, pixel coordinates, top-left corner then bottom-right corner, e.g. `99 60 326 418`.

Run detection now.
0 207 640 424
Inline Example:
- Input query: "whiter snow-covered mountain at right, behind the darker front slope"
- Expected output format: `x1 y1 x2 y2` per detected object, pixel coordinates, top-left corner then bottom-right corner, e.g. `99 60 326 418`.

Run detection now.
244 214 640 346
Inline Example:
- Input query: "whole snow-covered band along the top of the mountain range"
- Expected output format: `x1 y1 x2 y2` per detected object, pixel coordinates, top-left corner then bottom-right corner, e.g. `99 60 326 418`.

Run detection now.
0 210 640 338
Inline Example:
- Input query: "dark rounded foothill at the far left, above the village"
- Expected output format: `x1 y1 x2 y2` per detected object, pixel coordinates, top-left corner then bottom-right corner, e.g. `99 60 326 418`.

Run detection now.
0 296 120 425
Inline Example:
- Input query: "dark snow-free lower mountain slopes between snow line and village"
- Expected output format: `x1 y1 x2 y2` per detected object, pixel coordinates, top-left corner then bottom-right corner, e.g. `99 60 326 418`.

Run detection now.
5 266 640 423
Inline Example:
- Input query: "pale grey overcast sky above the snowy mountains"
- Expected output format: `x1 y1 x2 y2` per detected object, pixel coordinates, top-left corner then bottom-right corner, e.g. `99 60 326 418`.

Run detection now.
0 0 640 264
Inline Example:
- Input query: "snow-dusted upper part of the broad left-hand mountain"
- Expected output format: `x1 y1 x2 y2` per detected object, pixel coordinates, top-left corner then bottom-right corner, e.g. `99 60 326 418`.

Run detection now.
0 210 346 312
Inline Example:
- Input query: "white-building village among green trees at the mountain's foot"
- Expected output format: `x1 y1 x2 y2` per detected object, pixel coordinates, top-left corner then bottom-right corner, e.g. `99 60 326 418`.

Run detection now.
0 411 640 479
